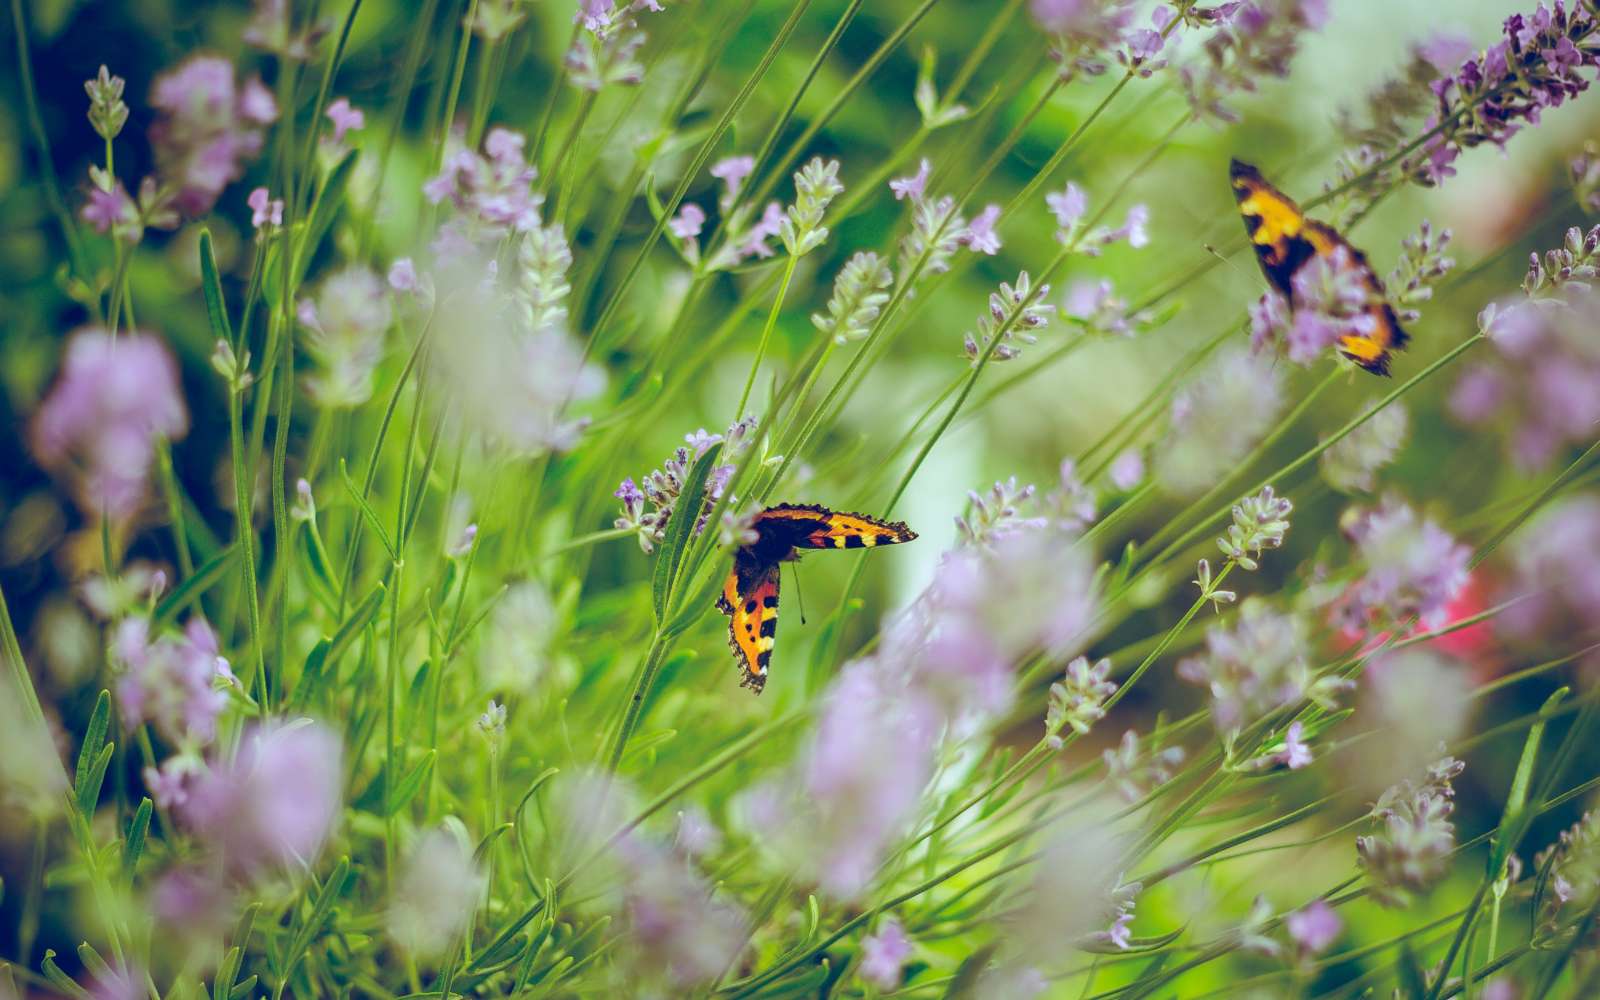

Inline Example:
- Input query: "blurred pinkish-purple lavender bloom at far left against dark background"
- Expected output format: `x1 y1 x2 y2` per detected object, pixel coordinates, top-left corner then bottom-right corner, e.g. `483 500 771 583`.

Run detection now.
32 328 189 522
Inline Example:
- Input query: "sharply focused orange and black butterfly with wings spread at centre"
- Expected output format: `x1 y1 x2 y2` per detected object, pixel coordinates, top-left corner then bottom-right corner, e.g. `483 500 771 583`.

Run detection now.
717 504 917 694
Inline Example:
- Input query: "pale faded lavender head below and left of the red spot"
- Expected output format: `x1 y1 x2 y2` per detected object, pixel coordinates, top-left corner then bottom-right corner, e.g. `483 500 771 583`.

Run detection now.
1178 598 1350 749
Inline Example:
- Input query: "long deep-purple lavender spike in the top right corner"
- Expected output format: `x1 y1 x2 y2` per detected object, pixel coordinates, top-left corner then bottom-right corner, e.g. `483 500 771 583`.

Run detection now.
1402 0 1600 186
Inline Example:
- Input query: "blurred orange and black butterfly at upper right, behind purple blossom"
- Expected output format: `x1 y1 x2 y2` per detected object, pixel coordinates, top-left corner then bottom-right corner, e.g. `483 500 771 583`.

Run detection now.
1227 160 1410 374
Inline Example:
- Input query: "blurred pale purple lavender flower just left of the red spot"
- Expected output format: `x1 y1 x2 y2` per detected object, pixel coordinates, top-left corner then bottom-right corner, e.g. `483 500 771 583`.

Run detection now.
1334 499 1472 630
